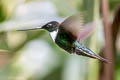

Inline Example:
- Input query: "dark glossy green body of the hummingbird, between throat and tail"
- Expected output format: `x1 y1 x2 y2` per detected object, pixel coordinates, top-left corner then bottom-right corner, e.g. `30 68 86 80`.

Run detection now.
55 29 75 52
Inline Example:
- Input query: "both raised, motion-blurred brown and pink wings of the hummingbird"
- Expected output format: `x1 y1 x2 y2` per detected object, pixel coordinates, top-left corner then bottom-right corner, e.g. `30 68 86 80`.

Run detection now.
60 13 96 41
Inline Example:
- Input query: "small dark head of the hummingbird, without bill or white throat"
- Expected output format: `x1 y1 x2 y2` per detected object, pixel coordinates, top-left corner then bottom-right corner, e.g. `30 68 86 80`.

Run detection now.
42 21 59 32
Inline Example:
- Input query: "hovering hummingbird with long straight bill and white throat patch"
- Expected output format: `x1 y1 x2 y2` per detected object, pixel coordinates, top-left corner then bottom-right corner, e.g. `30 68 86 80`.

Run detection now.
18 14 108 63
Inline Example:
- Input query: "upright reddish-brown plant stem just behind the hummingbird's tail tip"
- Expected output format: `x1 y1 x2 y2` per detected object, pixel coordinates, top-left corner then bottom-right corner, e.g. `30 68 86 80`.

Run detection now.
100 0 114 80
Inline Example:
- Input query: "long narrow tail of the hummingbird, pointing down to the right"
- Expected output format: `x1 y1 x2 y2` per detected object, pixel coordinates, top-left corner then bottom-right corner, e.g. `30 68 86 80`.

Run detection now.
74 41 108 63
